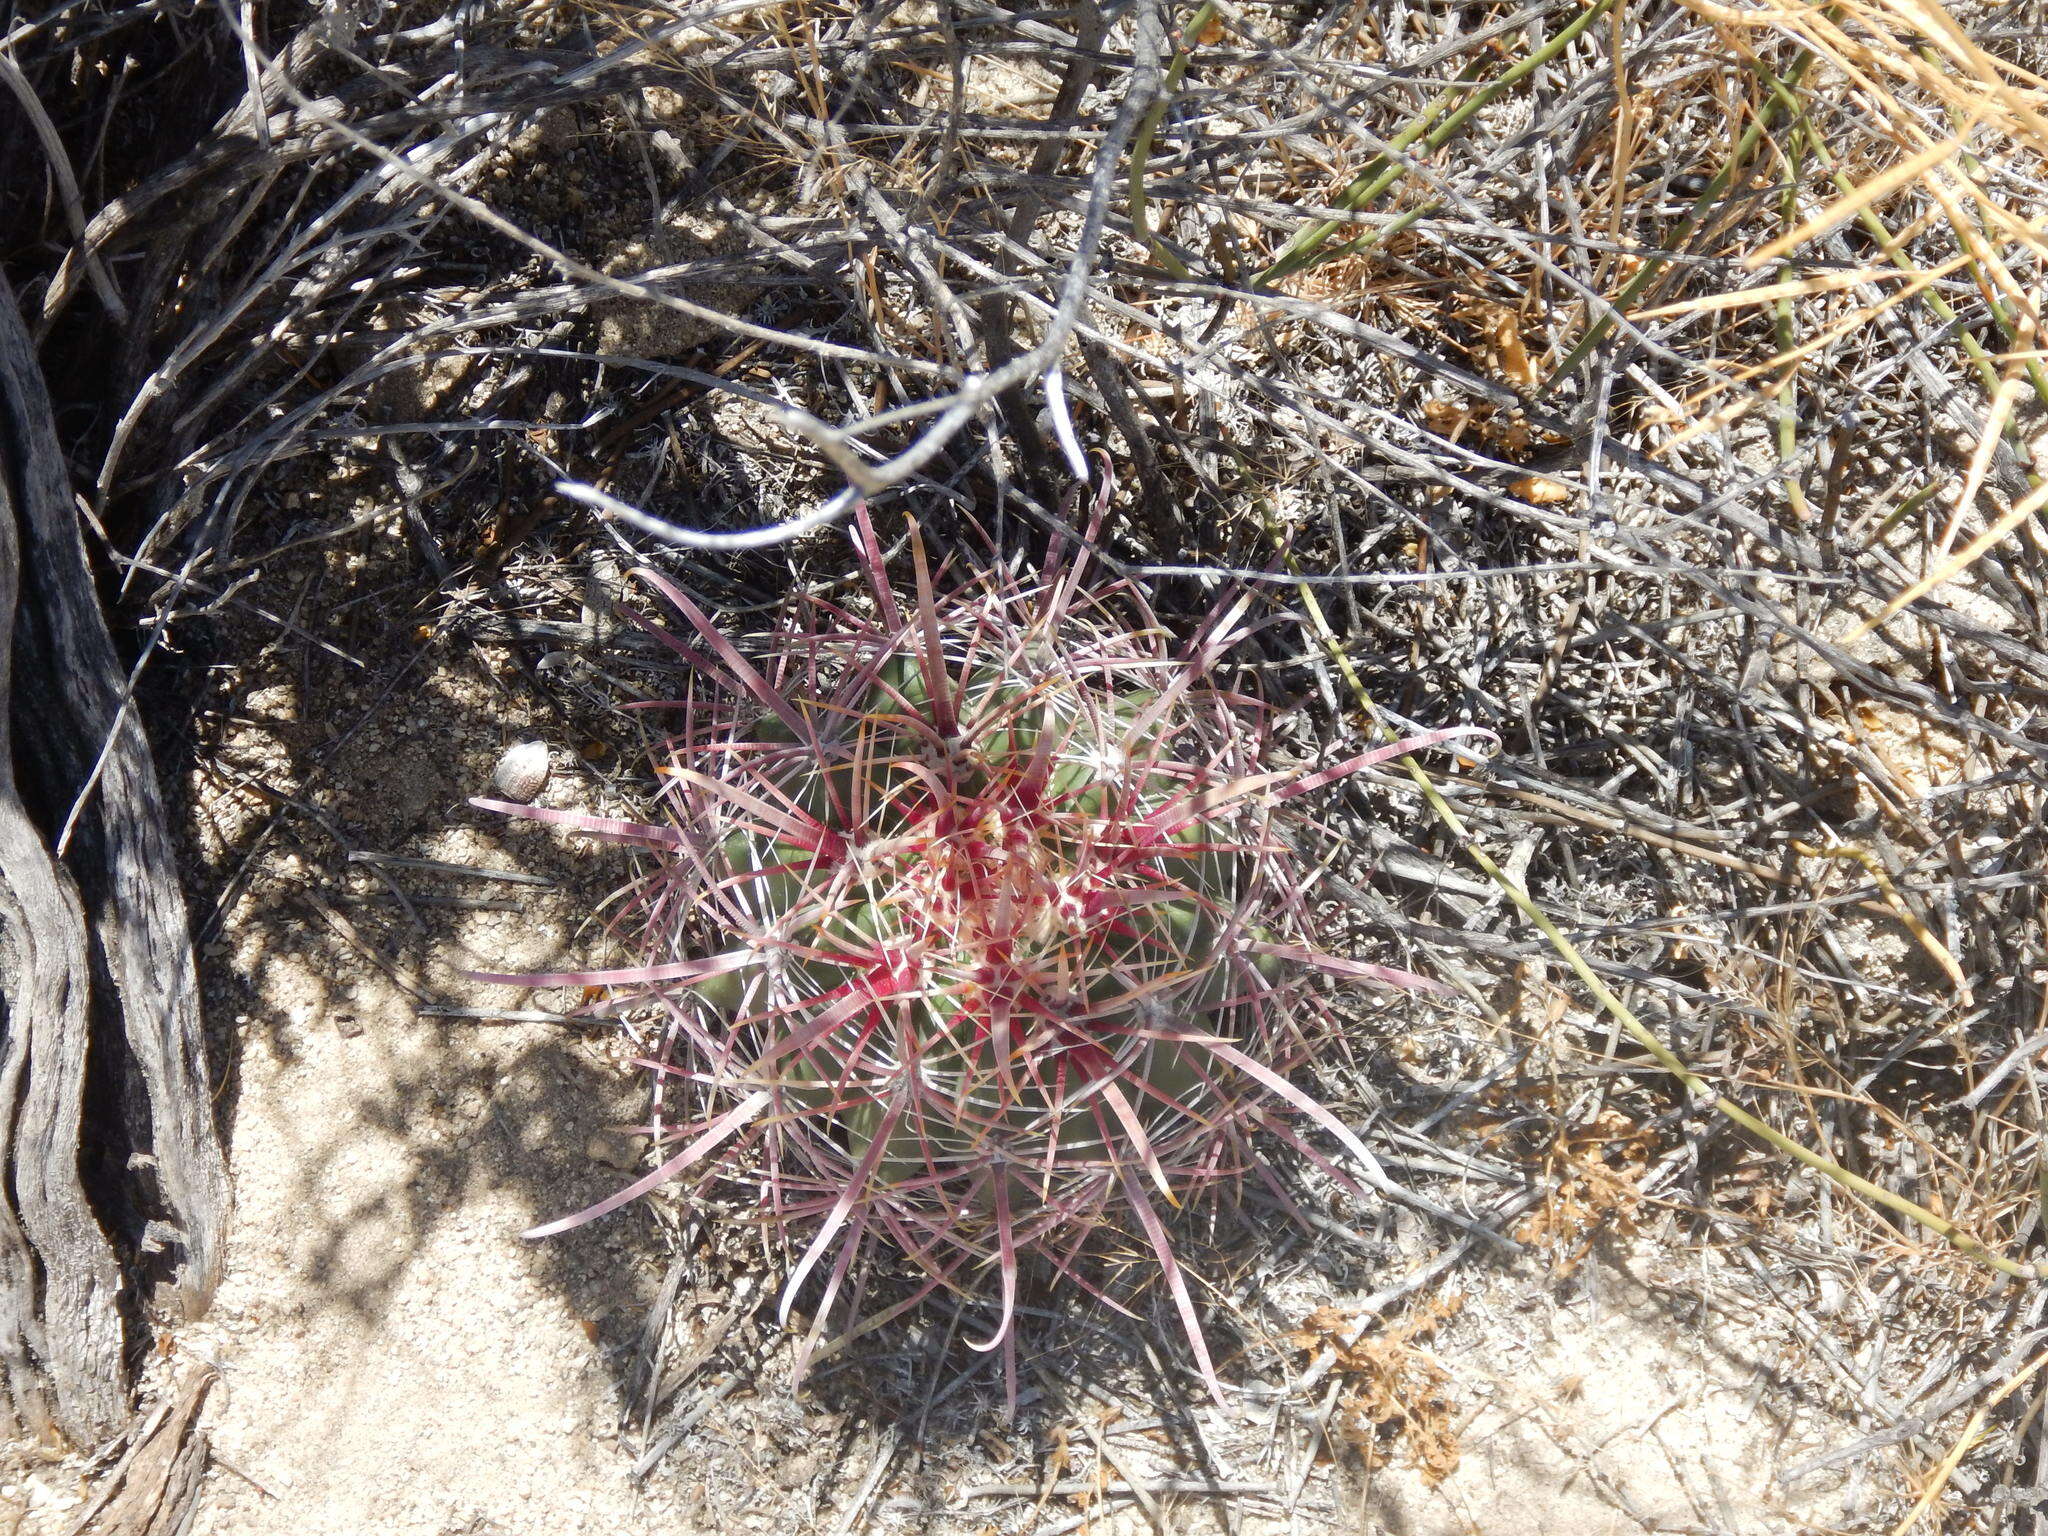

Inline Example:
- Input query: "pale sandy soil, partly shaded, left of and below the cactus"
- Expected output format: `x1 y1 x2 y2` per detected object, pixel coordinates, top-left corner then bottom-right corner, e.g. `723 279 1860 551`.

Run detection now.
0 528 1855 1536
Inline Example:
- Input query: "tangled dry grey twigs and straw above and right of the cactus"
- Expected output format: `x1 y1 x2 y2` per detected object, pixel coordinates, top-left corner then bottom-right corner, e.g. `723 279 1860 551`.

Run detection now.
12 0 2048 1524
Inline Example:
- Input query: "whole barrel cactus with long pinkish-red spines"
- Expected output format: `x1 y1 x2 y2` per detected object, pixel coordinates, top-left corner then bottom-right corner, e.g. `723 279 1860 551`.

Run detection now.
477 516 1475 1389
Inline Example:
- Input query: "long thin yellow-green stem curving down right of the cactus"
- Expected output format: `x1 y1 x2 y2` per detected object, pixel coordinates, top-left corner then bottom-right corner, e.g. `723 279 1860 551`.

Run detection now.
1288 540 2040 1280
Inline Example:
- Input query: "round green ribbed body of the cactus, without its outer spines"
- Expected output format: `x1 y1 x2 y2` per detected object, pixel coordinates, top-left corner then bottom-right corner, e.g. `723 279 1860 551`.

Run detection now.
729 655 1247 1206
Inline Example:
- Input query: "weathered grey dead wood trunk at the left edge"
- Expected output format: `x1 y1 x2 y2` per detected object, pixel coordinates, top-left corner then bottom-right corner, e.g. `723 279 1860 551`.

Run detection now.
0 279 227 1444
